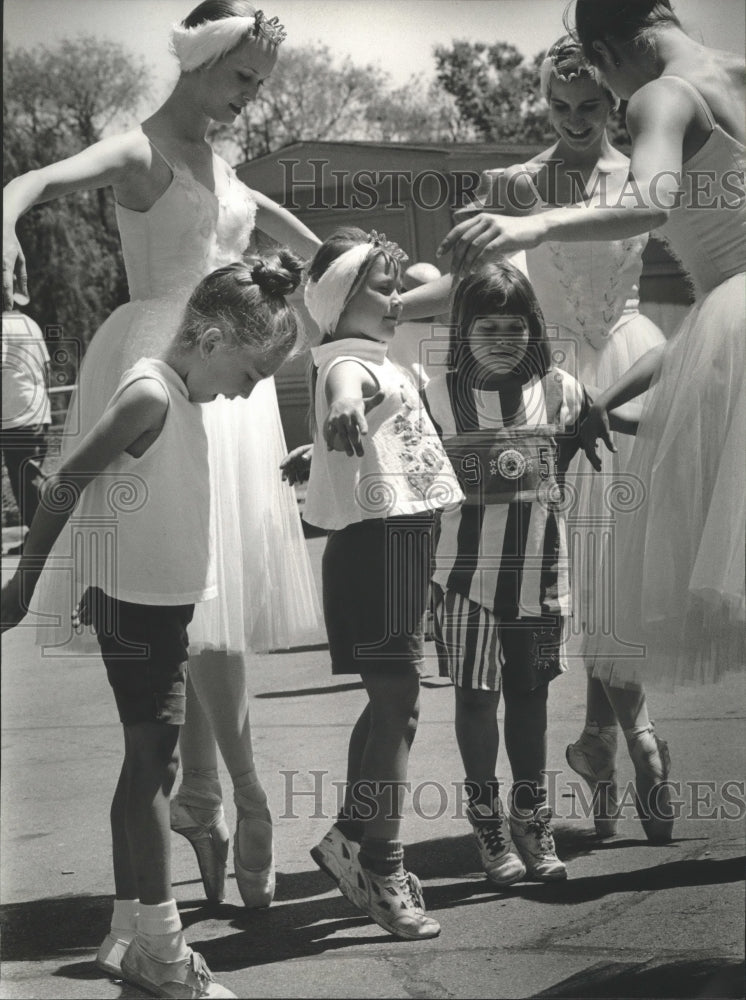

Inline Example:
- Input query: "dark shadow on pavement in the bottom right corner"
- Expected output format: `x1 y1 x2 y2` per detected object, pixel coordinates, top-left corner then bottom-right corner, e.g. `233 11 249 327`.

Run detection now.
535 958 746 1000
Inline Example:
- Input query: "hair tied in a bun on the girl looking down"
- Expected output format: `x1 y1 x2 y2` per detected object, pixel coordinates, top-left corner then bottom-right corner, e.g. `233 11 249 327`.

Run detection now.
179 250 303 355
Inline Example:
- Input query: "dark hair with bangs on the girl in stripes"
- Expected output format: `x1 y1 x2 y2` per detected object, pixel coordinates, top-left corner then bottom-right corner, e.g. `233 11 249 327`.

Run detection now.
449 260 552 382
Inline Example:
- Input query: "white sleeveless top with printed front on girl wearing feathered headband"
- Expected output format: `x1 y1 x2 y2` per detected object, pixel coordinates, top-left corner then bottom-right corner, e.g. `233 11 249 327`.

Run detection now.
303 338 463 531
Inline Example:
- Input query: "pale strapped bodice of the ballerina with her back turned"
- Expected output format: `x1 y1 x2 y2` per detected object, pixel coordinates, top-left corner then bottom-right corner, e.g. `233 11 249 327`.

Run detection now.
656 76 746 297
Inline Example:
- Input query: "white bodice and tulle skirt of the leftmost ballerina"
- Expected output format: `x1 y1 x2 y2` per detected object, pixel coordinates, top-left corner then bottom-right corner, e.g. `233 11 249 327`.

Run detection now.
32 147 319 655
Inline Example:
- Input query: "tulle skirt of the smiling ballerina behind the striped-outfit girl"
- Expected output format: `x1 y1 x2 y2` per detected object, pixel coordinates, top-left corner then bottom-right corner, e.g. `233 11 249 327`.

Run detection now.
560 311 665 620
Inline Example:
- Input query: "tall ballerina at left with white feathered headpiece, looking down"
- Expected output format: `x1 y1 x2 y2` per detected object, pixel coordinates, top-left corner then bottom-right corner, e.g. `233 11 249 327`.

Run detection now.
3 0 319 906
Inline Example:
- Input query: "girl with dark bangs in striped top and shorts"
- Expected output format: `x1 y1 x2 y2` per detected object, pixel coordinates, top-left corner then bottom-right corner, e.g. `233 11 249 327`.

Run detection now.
424 262 600 885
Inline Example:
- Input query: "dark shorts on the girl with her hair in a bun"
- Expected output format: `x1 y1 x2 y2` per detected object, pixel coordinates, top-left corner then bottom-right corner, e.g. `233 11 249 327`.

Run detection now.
85 587 194 726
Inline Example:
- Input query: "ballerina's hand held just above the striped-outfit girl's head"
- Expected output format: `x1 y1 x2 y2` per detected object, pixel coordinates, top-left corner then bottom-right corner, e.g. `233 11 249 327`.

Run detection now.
438 212 543 275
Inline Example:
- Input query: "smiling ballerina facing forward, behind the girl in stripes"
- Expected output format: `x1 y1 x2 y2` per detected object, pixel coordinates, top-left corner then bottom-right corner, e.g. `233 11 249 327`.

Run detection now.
460 35 663 837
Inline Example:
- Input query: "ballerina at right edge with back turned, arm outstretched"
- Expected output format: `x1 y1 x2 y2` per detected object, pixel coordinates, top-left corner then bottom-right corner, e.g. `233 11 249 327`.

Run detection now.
442 0 746 839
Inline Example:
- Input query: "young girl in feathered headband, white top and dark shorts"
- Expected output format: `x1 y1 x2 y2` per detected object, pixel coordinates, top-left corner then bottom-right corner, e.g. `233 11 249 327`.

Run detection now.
304 229 461 940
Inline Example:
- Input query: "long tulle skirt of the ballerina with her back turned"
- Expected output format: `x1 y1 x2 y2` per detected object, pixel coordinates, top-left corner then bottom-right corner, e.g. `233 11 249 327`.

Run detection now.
583 274 746 690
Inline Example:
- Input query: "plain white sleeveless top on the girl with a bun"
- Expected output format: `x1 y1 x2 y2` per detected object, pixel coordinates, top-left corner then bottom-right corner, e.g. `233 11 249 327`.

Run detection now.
80 358 217 605
